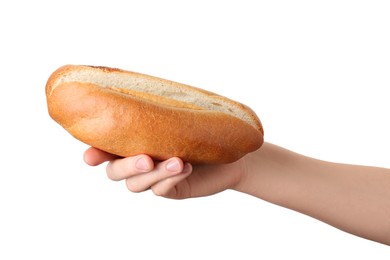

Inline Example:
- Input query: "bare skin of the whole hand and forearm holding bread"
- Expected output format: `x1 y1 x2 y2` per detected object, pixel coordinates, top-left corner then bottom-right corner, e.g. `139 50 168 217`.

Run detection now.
84 143 390 245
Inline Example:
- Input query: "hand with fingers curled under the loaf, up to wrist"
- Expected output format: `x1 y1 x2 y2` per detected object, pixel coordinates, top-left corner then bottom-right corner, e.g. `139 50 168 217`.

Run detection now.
84 147 245 199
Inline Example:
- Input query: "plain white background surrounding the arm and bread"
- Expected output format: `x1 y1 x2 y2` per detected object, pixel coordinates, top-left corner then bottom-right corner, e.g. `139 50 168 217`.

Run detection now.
0 0 390 259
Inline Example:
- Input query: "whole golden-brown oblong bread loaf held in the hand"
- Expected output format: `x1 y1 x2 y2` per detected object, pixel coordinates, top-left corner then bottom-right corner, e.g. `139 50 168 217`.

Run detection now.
46 65 263 164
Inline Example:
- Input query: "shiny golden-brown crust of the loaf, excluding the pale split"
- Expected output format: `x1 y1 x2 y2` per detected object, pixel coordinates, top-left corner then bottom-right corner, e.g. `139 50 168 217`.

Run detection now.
46 66 263 164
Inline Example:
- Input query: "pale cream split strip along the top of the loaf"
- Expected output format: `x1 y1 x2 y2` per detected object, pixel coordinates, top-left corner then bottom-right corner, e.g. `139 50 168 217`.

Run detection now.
52 67 260 129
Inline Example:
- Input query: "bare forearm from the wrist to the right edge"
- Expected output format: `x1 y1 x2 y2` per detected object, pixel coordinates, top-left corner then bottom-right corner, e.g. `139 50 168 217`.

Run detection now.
237 143 390 244
